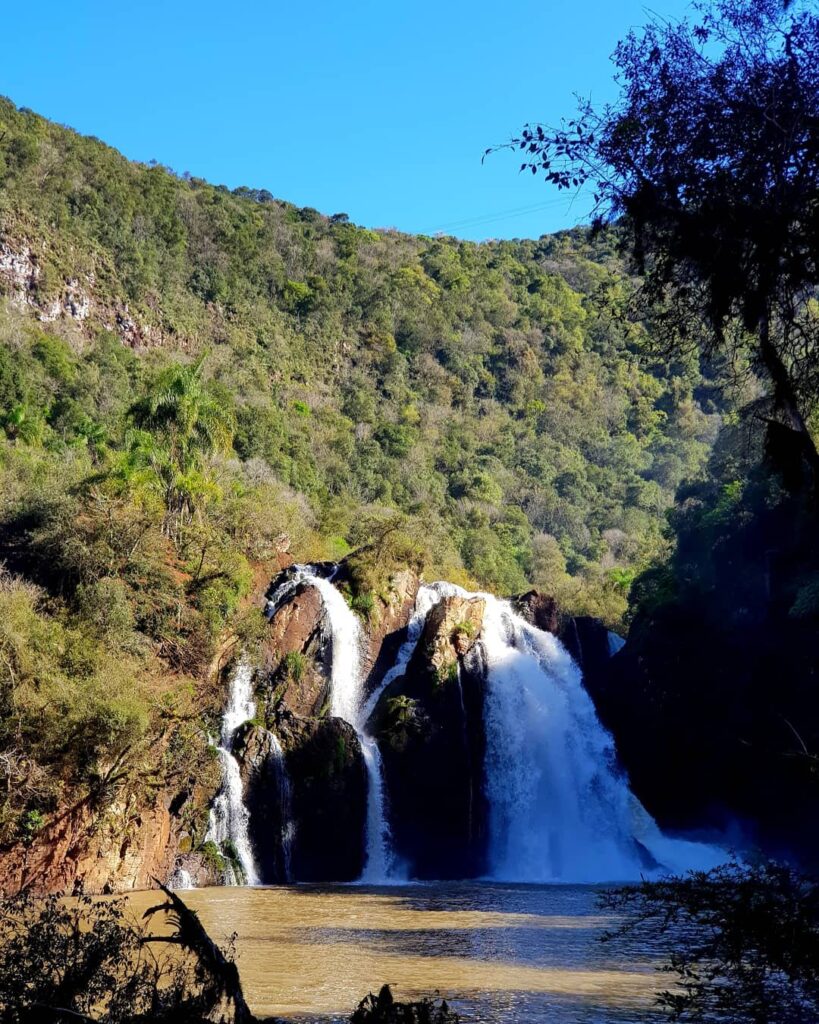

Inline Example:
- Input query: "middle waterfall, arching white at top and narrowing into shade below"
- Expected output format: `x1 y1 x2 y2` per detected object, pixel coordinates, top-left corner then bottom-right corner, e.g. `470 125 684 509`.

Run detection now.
268 565 396 883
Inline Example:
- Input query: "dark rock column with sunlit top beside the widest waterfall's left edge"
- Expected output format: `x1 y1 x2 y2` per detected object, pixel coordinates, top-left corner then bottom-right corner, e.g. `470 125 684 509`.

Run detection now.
373 597 486 879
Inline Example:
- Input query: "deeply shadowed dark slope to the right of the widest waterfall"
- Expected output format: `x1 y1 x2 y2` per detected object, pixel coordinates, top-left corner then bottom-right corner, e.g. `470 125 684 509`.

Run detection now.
594 415 819 865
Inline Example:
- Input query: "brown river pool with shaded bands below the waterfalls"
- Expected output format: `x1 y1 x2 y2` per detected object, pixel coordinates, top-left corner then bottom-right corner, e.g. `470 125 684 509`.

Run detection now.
130 883 662 1024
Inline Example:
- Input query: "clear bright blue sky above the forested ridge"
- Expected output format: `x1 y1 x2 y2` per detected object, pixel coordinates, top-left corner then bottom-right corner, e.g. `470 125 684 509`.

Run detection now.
0 0 688 239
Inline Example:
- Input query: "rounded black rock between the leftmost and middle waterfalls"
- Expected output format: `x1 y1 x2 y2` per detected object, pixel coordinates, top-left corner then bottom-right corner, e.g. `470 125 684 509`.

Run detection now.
274 717 367 882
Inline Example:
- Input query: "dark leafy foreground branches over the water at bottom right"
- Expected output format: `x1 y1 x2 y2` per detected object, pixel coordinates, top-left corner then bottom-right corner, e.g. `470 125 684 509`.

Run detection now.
602 863 819 1024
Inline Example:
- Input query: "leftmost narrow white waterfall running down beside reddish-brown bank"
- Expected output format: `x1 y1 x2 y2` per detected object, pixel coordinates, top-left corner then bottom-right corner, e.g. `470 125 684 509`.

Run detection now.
205 659 259 886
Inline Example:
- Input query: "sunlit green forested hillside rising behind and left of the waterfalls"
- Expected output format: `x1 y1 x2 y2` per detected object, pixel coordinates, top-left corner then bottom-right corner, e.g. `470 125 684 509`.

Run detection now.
0 100 720 856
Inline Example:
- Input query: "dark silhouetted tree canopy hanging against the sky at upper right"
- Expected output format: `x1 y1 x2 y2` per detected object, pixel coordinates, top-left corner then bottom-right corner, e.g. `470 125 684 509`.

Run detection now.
501 0 819 476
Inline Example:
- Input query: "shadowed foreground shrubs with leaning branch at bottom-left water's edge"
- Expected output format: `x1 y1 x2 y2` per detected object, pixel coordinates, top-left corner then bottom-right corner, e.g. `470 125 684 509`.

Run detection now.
0 890 247 1024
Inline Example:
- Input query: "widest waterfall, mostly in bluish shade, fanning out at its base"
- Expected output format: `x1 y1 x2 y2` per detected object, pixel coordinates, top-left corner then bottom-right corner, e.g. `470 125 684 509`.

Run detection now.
481 594 726 882
